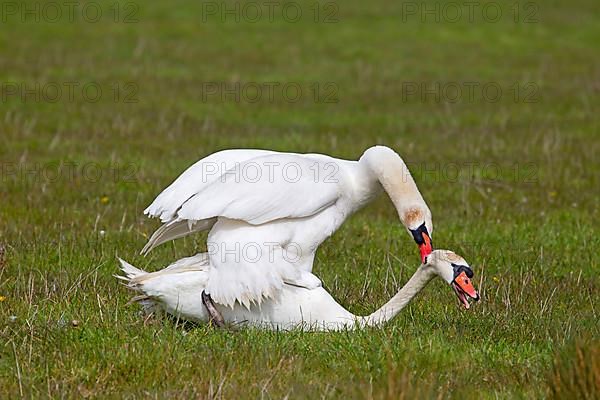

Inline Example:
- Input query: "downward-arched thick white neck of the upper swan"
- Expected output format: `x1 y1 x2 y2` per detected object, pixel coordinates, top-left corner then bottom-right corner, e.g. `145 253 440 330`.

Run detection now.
359 146 428 217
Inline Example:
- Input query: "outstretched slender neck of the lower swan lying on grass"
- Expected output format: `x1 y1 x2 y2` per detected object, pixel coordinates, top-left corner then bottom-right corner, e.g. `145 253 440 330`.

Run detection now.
359 265 435 326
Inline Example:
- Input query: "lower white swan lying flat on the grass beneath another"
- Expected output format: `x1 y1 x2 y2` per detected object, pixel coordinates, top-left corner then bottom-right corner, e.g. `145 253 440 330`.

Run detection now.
117 250 479 330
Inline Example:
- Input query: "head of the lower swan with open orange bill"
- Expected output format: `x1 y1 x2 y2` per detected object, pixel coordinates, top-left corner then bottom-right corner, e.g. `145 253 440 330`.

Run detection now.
423 250 479 309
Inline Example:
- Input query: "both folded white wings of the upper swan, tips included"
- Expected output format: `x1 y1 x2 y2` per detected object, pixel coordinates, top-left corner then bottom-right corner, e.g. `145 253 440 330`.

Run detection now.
142 150 339 254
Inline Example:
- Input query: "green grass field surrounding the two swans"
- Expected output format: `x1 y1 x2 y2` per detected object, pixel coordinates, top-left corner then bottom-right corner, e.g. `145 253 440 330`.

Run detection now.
0 0 600 399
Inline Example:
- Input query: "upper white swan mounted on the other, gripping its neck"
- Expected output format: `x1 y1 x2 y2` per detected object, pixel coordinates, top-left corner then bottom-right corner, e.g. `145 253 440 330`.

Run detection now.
142 146 433 308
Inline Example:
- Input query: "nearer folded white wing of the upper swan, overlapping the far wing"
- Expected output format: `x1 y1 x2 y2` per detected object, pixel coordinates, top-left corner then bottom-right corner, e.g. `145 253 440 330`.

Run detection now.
177 153 341 225
